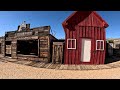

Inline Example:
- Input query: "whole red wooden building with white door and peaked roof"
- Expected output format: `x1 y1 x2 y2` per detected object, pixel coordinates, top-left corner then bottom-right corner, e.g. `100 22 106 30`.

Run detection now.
62 11 108 64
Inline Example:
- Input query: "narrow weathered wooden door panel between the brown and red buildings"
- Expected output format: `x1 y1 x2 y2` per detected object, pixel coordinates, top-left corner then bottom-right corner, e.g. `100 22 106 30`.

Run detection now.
52 42 64 63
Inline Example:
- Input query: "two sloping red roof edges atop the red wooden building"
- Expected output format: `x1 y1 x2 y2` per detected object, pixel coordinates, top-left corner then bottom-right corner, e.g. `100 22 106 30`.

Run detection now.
62 11 109 28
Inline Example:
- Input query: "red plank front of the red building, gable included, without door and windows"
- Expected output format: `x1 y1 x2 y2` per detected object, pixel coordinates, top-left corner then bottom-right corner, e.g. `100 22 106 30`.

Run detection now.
64 12 106 64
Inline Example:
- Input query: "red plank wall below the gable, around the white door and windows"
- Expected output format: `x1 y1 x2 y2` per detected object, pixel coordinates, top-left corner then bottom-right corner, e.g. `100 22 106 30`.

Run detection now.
64 26 106 64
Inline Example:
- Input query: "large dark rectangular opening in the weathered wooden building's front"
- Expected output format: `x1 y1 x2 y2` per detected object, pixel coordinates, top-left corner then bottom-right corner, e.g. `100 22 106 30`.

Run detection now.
17 40 38 56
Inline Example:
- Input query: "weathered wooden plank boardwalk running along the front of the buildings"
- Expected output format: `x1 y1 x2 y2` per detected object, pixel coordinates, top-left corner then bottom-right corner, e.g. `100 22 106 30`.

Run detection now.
0 58 120 71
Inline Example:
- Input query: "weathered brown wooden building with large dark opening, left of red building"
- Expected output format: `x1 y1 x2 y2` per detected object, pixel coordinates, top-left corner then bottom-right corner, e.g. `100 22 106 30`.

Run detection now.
0 22 57 62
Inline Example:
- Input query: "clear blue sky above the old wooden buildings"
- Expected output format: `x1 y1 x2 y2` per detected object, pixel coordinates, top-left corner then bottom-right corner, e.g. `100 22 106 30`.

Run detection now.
0 11 120 39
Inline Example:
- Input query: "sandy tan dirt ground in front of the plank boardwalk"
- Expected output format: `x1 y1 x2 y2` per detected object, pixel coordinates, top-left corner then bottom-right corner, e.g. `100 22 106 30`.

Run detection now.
0 62 120 79
